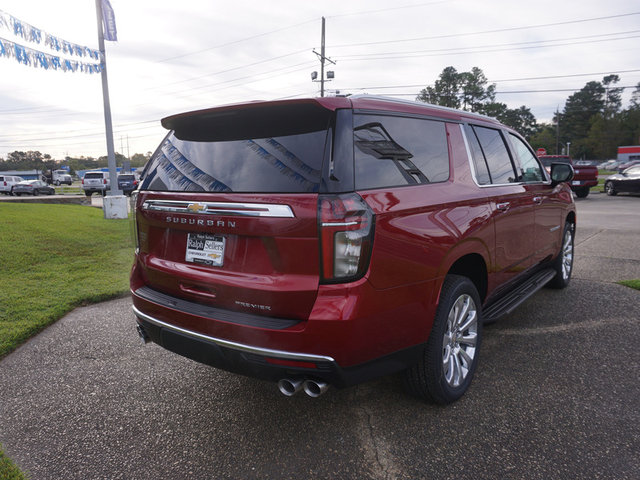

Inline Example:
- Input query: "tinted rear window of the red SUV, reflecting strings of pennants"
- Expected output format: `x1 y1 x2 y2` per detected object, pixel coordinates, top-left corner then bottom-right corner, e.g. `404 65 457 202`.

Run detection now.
141 105 331 193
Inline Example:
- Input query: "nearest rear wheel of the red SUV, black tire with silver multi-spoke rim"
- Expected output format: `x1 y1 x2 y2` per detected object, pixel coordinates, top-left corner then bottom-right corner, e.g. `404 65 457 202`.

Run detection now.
404 275 482 405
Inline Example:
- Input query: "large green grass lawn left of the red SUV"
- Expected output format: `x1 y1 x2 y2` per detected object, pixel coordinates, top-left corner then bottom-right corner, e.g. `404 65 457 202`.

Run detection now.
0 203 133 358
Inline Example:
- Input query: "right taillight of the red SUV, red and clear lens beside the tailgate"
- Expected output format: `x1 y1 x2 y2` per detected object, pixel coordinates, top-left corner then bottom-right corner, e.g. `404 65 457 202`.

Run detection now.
318 193 375 282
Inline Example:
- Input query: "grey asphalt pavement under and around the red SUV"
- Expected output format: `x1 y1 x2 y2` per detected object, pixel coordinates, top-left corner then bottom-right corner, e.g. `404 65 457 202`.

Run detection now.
0 194 640 480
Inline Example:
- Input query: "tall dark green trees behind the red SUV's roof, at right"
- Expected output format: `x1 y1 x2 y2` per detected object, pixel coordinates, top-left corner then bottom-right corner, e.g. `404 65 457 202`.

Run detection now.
416 67 640 160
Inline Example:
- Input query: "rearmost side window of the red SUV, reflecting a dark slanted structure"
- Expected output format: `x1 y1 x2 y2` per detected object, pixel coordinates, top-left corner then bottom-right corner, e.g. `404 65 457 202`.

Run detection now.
353 115 449 189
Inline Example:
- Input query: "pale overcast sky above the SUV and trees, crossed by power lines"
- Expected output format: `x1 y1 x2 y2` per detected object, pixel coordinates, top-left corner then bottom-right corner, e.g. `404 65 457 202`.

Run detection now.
0 0 640 159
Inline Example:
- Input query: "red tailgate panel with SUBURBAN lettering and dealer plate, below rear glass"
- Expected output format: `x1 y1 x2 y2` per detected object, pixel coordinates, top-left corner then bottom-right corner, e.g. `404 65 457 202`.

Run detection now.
137 192 319 318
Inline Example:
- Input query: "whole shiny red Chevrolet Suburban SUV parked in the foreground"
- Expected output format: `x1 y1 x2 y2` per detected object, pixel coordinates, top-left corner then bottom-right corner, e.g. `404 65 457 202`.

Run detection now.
131 96 576 403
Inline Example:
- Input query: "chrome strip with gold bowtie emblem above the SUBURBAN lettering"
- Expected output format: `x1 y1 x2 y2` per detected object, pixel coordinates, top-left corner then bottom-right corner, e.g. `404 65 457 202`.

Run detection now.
142 200 295 218
